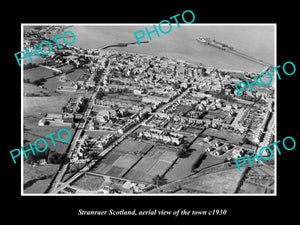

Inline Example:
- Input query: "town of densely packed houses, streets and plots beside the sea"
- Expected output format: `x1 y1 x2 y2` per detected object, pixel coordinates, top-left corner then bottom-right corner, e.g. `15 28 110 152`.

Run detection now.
24 26 276 194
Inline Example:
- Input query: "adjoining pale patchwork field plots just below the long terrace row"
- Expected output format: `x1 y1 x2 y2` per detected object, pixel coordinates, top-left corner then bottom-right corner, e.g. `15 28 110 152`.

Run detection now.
88 139 177 183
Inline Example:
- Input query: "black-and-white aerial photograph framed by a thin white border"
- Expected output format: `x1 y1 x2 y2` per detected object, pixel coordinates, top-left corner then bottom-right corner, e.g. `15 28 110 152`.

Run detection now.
21 23 277 196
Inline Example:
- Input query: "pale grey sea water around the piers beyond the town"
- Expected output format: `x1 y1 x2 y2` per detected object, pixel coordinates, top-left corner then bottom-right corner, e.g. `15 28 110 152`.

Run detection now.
68 24 275 72
